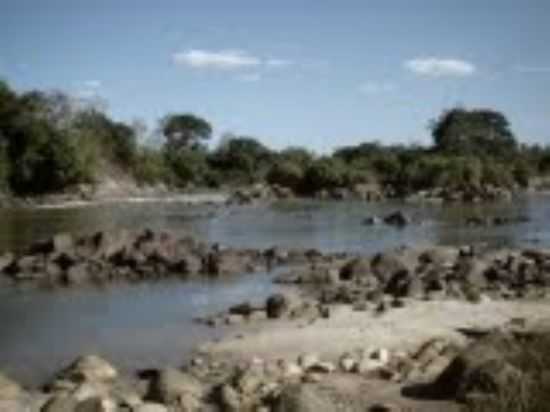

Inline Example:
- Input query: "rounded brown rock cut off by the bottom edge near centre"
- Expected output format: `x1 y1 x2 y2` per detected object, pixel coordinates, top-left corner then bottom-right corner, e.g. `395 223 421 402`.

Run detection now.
273 384 338 412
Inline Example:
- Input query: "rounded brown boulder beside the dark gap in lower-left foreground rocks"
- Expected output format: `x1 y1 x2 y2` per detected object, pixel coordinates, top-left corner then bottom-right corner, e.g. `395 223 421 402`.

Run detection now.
149 368 203 405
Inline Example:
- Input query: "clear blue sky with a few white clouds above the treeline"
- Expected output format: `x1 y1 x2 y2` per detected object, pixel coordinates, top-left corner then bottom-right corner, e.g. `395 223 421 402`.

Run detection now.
0 0 550 152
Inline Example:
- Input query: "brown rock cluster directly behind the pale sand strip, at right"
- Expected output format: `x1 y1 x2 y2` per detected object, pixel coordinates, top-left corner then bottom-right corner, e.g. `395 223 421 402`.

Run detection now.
275 246 550 312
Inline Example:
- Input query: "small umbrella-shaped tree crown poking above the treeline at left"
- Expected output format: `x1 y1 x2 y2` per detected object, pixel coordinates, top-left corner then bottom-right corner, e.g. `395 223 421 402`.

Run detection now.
161 114 212 150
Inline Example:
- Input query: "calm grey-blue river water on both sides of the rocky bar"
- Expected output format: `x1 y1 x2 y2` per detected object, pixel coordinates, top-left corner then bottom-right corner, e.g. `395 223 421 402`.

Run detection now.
0 195 550 384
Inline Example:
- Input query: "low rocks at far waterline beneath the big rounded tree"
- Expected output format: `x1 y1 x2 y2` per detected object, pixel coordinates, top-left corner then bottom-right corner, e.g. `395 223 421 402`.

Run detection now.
406 185 513 203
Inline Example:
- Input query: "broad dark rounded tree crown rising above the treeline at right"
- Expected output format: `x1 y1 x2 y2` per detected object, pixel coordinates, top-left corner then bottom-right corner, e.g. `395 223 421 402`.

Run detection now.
431 108 518 157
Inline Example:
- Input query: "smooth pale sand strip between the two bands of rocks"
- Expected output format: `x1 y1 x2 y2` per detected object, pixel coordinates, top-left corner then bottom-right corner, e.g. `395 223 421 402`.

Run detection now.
203 300 550 360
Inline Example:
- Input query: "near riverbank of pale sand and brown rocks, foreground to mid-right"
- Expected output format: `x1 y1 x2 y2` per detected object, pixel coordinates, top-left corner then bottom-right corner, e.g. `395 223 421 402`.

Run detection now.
0 233 550 412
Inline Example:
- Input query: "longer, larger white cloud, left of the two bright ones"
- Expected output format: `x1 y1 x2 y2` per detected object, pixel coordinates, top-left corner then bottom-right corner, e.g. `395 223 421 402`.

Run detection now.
176 49 262 70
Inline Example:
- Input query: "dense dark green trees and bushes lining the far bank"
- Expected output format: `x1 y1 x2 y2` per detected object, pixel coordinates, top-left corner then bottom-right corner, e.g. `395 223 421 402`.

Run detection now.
0 82 550 195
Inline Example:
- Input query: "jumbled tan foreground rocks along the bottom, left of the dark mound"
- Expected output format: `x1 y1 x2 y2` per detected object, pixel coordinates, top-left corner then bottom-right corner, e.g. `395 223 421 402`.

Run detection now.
0 334 468 412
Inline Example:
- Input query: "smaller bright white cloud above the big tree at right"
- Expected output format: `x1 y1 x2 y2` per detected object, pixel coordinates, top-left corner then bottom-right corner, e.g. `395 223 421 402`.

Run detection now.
404 57 476 77
